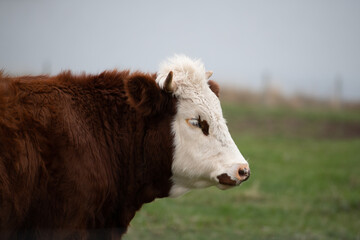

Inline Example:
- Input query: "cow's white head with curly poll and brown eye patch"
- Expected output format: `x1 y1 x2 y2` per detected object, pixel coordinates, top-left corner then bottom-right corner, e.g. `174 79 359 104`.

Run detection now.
156 55 250 197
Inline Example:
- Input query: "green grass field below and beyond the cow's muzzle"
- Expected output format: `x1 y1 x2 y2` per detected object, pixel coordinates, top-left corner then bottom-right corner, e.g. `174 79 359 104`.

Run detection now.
124 104 360 240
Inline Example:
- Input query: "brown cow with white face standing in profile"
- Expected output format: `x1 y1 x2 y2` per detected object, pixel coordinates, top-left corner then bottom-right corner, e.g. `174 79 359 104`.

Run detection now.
0 55 250 239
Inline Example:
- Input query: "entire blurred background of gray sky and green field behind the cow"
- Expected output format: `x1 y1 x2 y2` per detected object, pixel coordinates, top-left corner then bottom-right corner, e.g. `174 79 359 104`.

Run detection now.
0 0 360 239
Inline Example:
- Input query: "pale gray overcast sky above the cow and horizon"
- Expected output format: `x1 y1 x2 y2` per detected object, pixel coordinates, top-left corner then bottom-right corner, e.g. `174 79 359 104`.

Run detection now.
0 0 360 100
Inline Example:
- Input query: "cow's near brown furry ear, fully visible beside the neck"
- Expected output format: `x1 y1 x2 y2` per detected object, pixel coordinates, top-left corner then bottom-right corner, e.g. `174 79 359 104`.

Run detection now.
125 74 163 116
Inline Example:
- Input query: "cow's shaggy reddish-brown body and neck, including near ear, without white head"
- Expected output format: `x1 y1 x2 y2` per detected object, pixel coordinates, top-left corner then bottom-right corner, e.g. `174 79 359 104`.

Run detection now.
0 71 176 239
